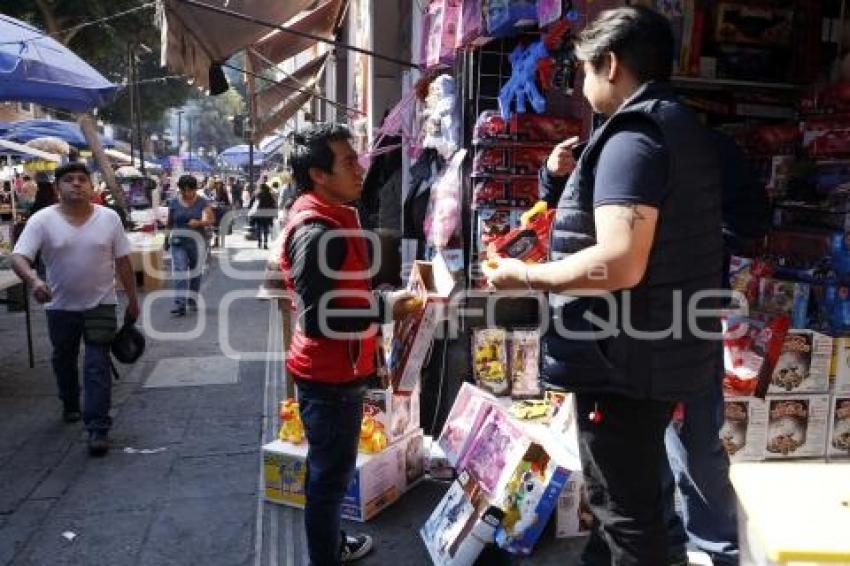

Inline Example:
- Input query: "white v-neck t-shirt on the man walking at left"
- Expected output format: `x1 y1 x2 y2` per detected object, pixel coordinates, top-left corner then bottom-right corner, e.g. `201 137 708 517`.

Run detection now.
13 205 130 311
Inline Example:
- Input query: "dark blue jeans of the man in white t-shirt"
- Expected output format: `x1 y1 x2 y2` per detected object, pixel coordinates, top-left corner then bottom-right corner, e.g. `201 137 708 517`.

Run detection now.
46 309 112 431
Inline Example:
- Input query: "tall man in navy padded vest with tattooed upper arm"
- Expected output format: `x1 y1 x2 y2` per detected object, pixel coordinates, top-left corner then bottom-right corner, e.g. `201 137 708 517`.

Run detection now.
485 7 723 566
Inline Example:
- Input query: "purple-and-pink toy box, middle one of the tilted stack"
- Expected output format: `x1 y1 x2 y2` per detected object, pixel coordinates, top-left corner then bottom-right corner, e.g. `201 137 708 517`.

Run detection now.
458 409 531 498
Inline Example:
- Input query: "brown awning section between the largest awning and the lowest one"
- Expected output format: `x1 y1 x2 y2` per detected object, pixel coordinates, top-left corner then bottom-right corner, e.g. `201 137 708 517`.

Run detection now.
248 0 348 72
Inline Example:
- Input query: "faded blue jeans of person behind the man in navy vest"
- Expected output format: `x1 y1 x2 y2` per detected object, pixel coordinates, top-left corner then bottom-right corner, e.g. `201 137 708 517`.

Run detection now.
664 380 738 566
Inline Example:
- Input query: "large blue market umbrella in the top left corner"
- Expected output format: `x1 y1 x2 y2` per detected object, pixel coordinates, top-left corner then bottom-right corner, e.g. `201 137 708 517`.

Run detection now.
0 14 118 112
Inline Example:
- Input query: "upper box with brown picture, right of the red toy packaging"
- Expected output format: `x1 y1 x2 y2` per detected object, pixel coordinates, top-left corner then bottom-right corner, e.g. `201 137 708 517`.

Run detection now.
767 330 832 393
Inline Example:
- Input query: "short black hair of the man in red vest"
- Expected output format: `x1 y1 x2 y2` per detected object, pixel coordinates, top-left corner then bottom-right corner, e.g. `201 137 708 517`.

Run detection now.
290 122 351 194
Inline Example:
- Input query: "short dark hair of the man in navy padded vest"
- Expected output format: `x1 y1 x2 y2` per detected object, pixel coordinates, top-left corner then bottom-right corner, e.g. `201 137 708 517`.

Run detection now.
575 6 674 83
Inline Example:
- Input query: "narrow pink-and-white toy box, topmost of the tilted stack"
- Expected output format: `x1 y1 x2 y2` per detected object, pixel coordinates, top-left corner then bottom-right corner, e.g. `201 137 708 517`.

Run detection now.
437 383 497 466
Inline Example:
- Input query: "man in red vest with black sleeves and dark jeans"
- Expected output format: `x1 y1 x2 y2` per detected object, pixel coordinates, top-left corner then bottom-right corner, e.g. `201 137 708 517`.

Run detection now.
280 124 421 566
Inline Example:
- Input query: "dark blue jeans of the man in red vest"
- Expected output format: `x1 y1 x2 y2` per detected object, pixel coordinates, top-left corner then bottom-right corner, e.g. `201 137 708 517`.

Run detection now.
297 381 366 566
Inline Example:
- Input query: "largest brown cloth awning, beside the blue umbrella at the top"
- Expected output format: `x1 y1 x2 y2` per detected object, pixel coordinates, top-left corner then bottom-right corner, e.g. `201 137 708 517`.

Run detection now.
159 0 315 88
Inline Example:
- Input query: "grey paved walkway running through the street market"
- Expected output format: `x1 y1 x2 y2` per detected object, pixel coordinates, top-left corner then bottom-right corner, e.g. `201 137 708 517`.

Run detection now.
0 224 580 566
